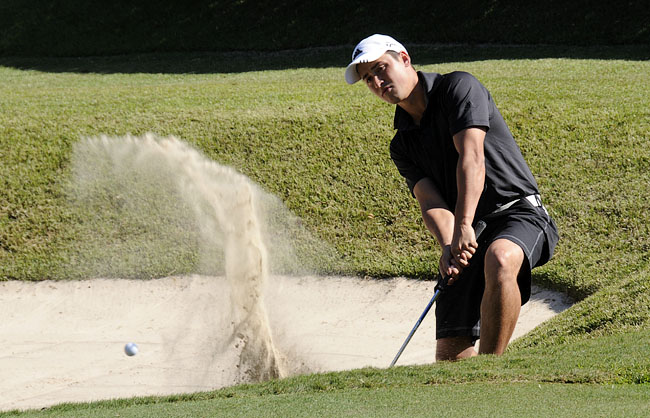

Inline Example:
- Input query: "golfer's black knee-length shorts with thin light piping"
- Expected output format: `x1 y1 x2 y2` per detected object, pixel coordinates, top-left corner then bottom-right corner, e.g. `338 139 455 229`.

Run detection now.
436 199 559 341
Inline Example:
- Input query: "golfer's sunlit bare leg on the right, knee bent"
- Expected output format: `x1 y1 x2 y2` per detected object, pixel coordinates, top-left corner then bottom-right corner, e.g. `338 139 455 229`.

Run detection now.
479 239 524 354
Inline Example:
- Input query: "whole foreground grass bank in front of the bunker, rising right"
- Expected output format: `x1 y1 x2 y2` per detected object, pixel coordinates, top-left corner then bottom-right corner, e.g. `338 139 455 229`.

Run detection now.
6 329 650 417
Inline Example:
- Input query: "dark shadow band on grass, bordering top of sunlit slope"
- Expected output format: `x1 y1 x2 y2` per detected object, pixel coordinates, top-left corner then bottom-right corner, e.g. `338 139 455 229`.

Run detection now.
0 45 650 74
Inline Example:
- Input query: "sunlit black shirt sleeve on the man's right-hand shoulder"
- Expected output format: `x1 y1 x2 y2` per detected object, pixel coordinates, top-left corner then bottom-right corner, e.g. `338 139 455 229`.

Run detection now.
442 71 492 136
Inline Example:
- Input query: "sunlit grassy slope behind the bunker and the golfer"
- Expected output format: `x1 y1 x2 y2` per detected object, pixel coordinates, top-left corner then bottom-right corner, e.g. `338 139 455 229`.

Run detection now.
0 48 650 298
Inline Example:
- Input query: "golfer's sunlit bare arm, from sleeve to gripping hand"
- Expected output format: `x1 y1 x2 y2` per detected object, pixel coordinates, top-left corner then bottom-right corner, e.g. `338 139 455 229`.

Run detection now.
451 128 485 267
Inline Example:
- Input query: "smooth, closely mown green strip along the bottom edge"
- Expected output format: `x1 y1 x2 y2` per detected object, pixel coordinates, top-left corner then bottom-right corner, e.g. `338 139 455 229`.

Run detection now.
6 383 650 417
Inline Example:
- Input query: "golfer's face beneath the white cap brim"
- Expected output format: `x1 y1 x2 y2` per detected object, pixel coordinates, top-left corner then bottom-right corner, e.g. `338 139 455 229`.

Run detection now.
357 53 417 104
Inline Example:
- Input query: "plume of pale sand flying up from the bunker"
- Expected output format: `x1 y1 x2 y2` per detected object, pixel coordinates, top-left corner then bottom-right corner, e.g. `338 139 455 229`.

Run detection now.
67 134 322 381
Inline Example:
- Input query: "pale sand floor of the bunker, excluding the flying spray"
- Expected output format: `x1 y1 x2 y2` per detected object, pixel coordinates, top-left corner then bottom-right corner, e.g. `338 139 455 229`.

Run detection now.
0 276 570 410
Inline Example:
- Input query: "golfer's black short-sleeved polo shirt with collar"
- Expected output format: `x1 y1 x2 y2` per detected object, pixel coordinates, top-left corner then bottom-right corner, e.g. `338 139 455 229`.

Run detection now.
390 72 539 220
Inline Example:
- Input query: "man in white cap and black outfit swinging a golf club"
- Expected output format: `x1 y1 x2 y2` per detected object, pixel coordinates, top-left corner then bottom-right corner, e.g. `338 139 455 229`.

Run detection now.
345 35 558 360
